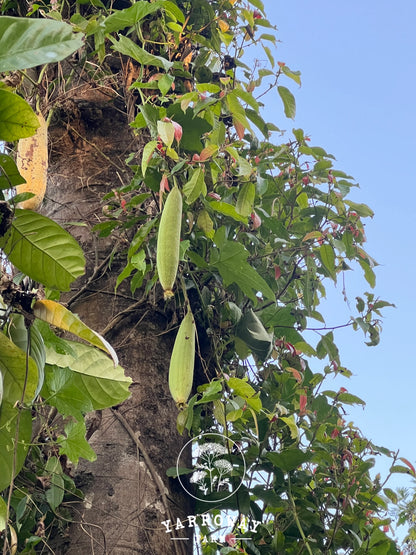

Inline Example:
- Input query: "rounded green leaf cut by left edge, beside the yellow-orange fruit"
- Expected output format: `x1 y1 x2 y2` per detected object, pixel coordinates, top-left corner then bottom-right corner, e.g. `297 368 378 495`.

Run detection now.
0 89 39 141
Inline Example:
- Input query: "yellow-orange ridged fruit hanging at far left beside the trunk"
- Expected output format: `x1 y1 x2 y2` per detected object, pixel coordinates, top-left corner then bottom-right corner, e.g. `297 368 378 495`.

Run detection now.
16 113 48 210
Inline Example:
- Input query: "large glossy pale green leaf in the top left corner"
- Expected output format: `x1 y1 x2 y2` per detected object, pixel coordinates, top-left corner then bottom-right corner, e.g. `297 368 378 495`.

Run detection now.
0 16 83 72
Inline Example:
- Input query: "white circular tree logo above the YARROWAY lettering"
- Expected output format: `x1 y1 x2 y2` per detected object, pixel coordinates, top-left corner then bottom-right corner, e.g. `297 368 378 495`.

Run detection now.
176 432 246 503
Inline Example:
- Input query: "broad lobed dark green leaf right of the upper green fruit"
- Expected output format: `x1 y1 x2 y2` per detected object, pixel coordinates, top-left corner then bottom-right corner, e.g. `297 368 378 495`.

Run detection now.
214 241 275 302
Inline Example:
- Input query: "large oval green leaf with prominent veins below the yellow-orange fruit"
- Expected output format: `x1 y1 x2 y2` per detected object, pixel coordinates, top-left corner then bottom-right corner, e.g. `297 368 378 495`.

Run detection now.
0 209 85 291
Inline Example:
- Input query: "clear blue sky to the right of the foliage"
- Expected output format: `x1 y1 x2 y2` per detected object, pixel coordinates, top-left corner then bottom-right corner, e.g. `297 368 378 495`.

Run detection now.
264 0 416 500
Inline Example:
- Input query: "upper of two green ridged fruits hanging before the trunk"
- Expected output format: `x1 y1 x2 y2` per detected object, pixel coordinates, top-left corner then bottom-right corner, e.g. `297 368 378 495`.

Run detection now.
156 185 182 299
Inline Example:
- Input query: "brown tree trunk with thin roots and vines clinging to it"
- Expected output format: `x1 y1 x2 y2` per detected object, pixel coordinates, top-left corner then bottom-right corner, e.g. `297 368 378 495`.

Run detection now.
40 63 192 555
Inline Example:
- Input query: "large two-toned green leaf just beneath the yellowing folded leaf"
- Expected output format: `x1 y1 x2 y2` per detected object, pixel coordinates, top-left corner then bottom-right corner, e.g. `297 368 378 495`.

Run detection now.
42 341 131 419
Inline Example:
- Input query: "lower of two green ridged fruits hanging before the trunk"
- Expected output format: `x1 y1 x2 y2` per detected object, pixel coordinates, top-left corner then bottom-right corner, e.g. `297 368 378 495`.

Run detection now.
169 308 196 409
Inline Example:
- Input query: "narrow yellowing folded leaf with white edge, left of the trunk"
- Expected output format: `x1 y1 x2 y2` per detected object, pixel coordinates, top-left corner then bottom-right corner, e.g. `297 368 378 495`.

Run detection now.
33 299 118 366
